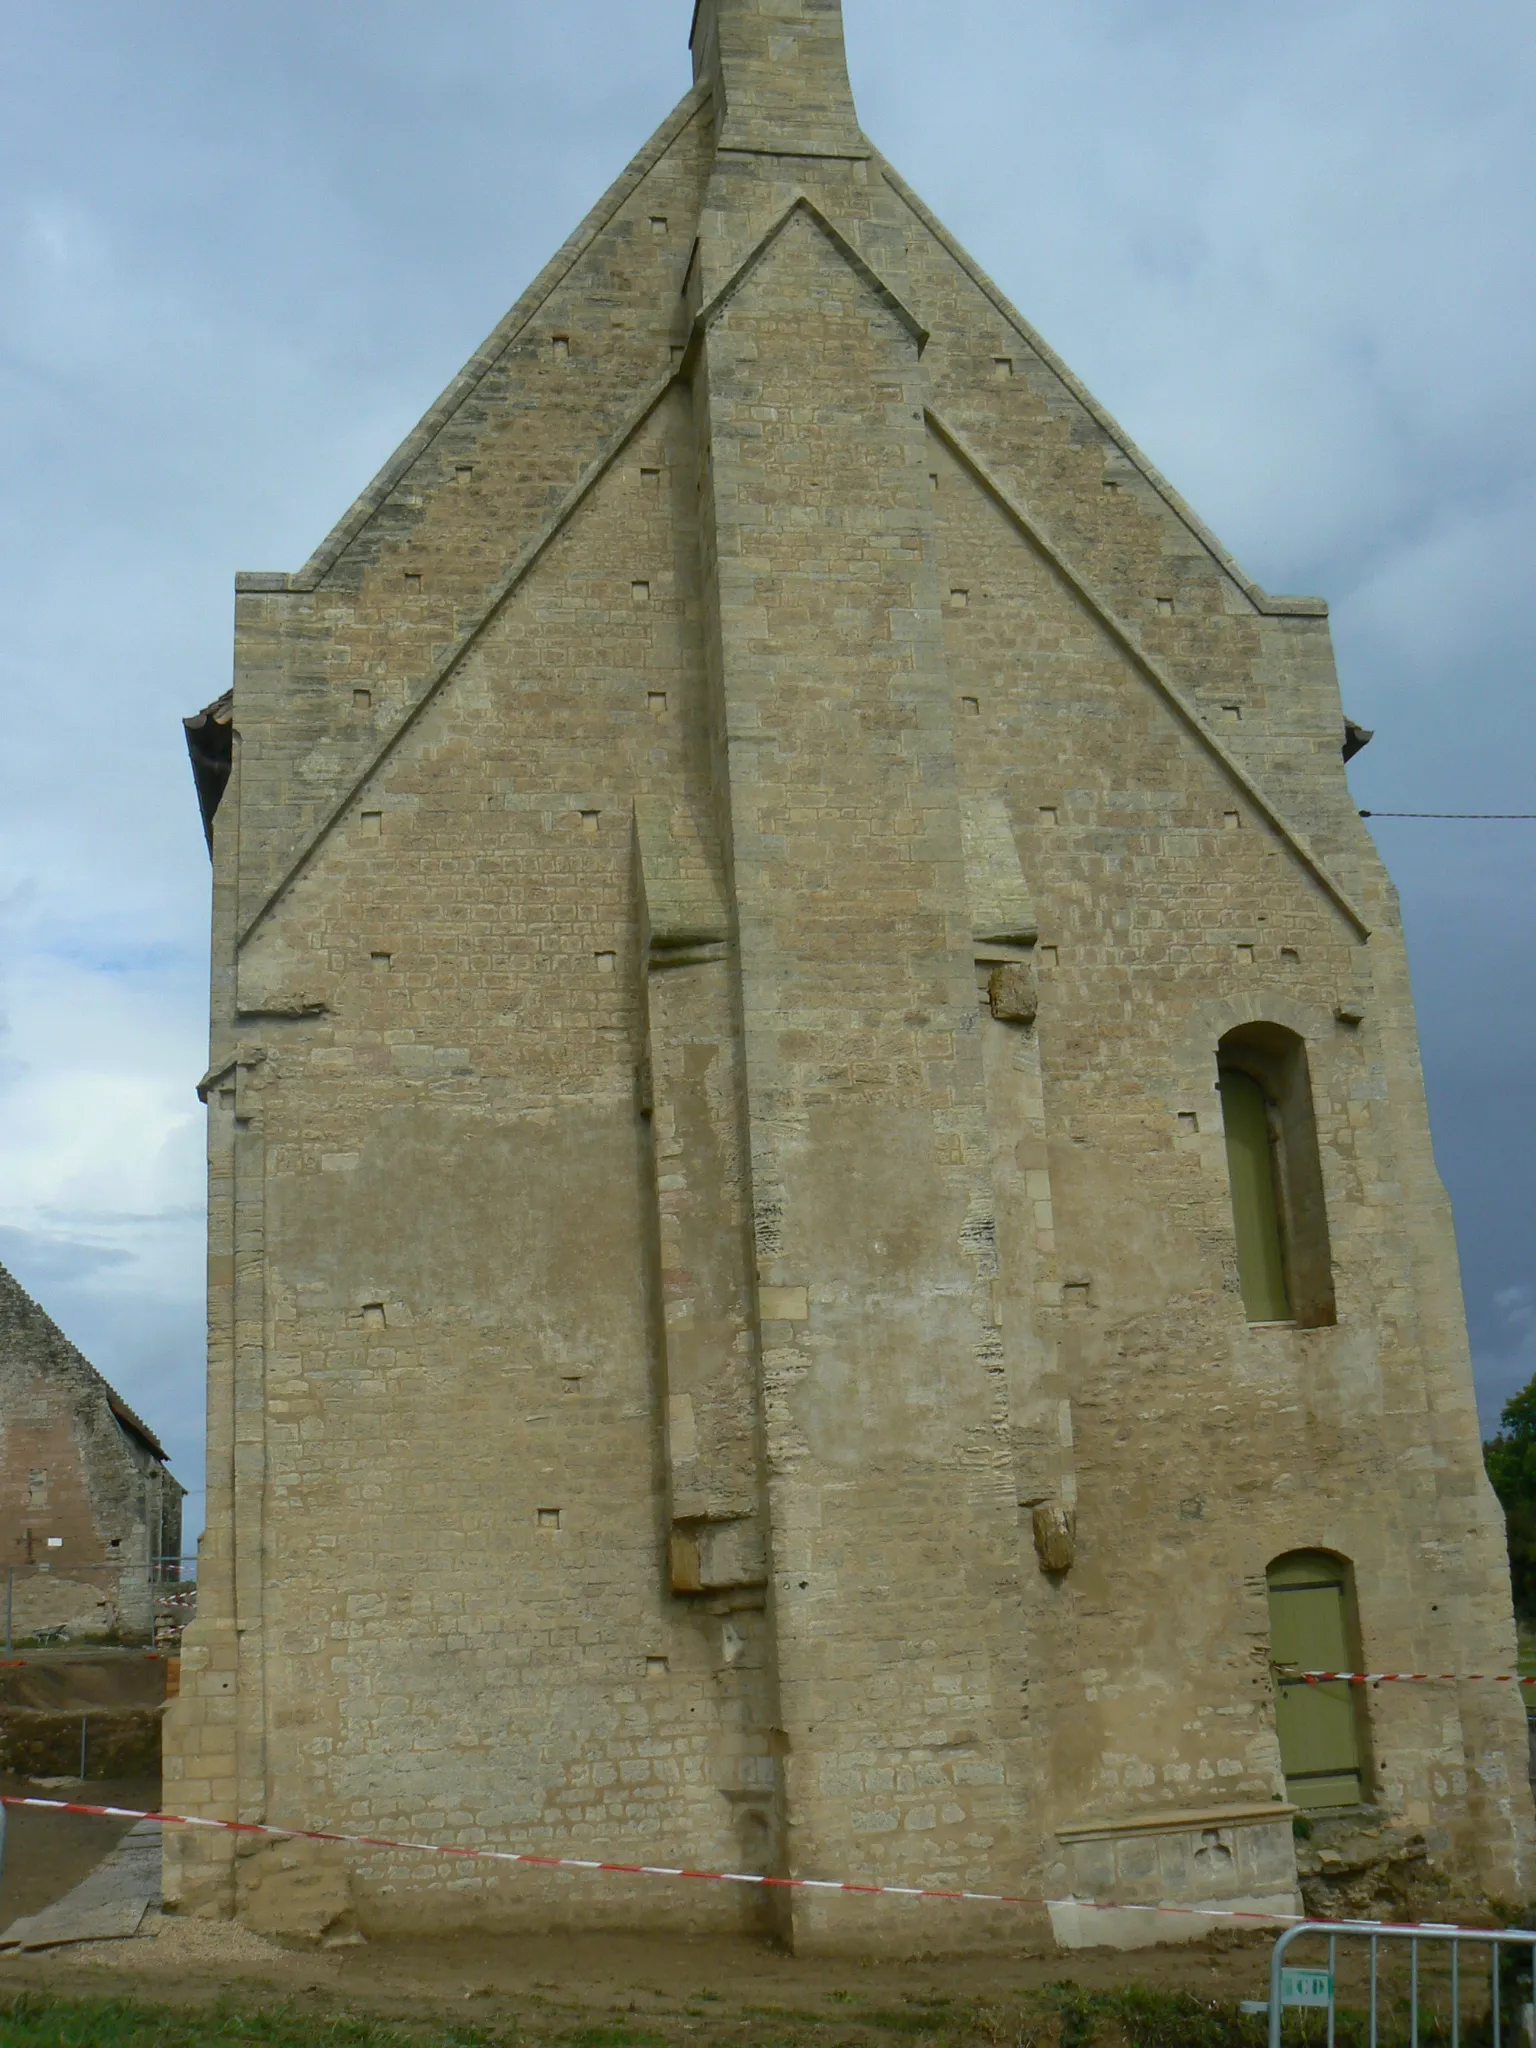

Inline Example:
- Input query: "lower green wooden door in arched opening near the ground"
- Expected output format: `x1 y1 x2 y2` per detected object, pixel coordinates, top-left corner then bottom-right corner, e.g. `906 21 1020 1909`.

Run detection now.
1270 1550 1360 1806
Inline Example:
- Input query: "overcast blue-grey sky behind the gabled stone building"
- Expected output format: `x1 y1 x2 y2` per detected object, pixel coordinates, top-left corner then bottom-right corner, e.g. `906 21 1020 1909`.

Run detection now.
0 0 1536 1540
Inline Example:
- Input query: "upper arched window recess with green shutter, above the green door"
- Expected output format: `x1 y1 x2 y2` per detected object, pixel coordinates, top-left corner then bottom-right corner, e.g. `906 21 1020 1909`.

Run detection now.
1217 1024 1337 1329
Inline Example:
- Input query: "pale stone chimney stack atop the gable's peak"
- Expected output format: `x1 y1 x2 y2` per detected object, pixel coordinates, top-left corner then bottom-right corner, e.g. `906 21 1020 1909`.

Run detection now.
692 0 868 158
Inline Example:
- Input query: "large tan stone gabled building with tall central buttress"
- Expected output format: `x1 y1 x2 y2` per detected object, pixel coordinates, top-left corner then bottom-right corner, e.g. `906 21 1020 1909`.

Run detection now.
166 0 1532 1948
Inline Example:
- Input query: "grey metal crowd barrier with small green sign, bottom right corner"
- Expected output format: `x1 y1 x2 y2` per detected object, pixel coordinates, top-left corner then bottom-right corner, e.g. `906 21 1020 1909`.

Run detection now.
1245 1921 1536 2048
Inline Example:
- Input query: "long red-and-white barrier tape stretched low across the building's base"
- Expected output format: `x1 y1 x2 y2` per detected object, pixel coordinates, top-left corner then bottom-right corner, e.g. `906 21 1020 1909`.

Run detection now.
0 1794 1536 1946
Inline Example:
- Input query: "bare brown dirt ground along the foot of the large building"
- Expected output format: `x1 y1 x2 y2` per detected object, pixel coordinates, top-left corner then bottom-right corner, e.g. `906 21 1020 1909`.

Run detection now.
0 1782 1507 2048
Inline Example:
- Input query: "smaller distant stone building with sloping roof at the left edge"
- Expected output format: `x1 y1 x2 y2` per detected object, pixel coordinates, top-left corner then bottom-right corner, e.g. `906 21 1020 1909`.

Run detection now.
0 1266 184 1642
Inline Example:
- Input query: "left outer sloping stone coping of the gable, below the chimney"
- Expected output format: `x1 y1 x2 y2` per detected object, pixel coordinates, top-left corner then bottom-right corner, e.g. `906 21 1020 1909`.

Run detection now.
236 84 711 596
